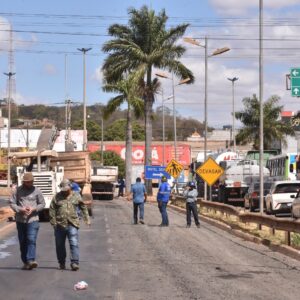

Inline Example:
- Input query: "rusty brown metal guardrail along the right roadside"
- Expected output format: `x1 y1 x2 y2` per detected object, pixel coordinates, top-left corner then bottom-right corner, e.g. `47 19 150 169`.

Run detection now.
172 196 300 245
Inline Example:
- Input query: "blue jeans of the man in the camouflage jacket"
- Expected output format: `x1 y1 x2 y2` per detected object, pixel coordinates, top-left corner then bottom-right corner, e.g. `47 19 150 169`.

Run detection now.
54 225 79 265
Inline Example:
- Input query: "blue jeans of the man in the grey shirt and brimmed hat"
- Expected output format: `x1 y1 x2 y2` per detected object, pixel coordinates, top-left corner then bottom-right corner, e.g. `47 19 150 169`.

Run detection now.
17 221 40 264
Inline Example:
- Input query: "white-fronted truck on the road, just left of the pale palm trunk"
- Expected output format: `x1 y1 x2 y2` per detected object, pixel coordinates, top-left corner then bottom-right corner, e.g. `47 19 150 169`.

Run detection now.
91 161 118 200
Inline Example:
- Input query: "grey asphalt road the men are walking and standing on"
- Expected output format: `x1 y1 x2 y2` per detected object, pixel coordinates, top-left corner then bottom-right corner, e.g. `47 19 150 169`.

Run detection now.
0 199 300 300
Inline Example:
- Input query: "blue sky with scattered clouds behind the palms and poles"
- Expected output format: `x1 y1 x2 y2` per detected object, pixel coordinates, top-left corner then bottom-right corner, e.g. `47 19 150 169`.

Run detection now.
0 0 300 128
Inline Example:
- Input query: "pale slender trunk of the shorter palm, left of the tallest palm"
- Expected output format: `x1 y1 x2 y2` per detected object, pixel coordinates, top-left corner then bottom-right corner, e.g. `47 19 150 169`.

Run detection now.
125 104 132 195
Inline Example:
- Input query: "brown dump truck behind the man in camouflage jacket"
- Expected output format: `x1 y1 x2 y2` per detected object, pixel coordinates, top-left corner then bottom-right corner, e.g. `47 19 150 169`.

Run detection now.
50 151 93 216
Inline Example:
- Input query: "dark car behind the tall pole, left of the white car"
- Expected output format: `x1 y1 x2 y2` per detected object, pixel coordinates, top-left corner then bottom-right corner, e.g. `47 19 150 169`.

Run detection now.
244 181 273 212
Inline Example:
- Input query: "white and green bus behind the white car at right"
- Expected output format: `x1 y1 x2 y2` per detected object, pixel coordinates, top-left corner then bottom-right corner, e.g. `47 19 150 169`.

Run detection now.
266 153 297 180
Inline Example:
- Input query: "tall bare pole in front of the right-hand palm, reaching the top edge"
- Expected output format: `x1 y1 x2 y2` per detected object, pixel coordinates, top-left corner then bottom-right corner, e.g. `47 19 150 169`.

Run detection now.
259 0 264 214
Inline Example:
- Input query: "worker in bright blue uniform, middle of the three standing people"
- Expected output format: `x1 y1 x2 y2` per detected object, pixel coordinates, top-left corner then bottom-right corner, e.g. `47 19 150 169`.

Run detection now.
157 176 171 227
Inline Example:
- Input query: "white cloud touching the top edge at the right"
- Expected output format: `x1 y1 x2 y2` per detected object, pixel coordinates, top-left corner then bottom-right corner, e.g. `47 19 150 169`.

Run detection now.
210 0 299 16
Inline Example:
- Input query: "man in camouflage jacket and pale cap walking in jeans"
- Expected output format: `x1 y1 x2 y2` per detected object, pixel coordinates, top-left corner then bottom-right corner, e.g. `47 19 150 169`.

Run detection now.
49 179 90 271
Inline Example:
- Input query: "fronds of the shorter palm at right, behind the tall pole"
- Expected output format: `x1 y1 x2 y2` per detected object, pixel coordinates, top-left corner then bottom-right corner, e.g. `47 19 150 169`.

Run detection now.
235 95 294 150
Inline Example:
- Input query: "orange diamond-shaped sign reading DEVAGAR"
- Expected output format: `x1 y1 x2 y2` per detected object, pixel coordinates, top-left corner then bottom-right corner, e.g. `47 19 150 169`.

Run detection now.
196 157 224 185
